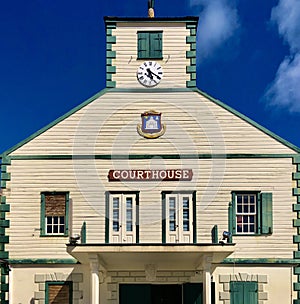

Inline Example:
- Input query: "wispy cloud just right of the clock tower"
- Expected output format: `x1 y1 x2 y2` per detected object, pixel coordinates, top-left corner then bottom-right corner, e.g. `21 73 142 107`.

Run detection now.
190 0 239 60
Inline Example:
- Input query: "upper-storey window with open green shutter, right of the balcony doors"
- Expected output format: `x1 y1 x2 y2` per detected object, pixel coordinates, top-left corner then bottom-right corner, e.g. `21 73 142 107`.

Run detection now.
229 191 273 235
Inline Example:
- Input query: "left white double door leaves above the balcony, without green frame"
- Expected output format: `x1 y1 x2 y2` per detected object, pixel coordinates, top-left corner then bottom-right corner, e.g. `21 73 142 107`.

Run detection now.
109 193 136 243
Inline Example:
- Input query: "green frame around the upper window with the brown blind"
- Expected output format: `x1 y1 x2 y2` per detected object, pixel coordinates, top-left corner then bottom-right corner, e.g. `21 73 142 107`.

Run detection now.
40 191 70 238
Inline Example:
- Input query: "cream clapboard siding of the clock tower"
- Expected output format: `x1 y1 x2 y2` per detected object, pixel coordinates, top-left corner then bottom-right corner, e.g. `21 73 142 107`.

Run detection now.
112 23 190 88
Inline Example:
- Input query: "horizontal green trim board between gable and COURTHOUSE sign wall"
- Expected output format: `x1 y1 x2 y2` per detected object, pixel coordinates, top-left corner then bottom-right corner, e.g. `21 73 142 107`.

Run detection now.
6 154 293 160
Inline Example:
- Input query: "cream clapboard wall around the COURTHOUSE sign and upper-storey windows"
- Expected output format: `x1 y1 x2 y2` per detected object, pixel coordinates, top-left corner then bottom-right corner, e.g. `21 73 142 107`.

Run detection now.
4 158 296 258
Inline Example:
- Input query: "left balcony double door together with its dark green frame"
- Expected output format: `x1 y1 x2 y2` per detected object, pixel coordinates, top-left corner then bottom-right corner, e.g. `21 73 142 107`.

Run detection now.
105 192 139 243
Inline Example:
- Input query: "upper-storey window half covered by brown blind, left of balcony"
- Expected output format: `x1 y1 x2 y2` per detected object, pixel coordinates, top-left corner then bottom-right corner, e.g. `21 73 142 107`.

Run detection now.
41 192 69 236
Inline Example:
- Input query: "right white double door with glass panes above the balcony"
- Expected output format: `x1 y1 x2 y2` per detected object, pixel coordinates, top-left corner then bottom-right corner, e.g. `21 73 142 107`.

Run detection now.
166 193 193 243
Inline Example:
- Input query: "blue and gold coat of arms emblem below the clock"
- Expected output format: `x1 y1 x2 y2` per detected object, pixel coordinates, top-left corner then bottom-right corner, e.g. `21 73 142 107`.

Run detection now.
137 110 166 138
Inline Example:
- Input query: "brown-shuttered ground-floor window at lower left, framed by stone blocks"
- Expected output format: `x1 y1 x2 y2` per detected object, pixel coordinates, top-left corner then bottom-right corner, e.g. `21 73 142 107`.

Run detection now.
45 281 73 304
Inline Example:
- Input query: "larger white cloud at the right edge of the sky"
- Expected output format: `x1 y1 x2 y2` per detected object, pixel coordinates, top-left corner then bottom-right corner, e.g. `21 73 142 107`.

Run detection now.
264 0 300 112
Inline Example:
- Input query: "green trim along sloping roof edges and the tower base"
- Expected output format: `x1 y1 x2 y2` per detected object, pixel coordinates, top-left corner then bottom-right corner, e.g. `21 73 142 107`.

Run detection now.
0 88 300 158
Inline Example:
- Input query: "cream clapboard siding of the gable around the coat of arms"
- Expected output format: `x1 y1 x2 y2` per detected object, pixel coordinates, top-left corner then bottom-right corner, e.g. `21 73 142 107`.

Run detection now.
12 91 295 155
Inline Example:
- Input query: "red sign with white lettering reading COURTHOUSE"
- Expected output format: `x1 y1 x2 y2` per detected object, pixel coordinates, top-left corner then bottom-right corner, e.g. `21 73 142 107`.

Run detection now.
108 169 193 182
